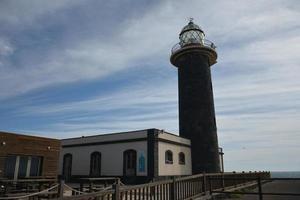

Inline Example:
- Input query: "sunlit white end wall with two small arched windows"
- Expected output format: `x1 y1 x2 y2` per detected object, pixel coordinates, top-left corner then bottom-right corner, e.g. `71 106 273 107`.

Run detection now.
158 142 192 176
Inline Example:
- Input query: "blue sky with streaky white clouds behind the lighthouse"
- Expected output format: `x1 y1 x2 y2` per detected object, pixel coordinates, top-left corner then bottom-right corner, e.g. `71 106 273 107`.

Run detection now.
0 0 300 171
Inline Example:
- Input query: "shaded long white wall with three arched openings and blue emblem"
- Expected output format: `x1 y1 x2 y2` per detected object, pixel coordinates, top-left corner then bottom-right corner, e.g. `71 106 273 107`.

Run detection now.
59 141 148 176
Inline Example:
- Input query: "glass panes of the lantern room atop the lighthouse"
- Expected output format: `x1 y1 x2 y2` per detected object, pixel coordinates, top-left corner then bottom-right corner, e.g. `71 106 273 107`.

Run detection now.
179 30 204 46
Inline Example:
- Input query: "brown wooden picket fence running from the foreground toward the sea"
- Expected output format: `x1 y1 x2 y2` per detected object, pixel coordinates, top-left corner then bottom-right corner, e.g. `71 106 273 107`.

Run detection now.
54 172 270 200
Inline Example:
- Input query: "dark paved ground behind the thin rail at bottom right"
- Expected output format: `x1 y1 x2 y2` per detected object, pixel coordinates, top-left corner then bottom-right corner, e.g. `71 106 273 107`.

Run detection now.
224 180 300 200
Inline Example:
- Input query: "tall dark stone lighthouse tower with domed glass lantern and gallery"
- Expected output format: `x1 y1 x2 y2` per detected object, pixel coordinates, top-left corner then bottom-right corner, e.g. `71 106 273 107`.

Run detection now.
170 20 220 174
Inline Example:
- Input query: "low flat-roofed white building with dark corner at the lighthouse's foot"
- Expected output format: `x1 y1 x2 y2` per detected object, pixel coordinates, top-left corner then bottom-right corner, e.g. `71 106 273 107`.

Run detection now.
59 129 192 182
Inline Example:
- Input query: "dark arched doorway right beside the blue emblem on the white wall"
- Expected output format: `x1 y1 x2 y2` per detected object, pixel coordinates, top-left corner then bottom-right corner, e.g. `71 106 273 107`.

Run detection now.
123 149 136 176
